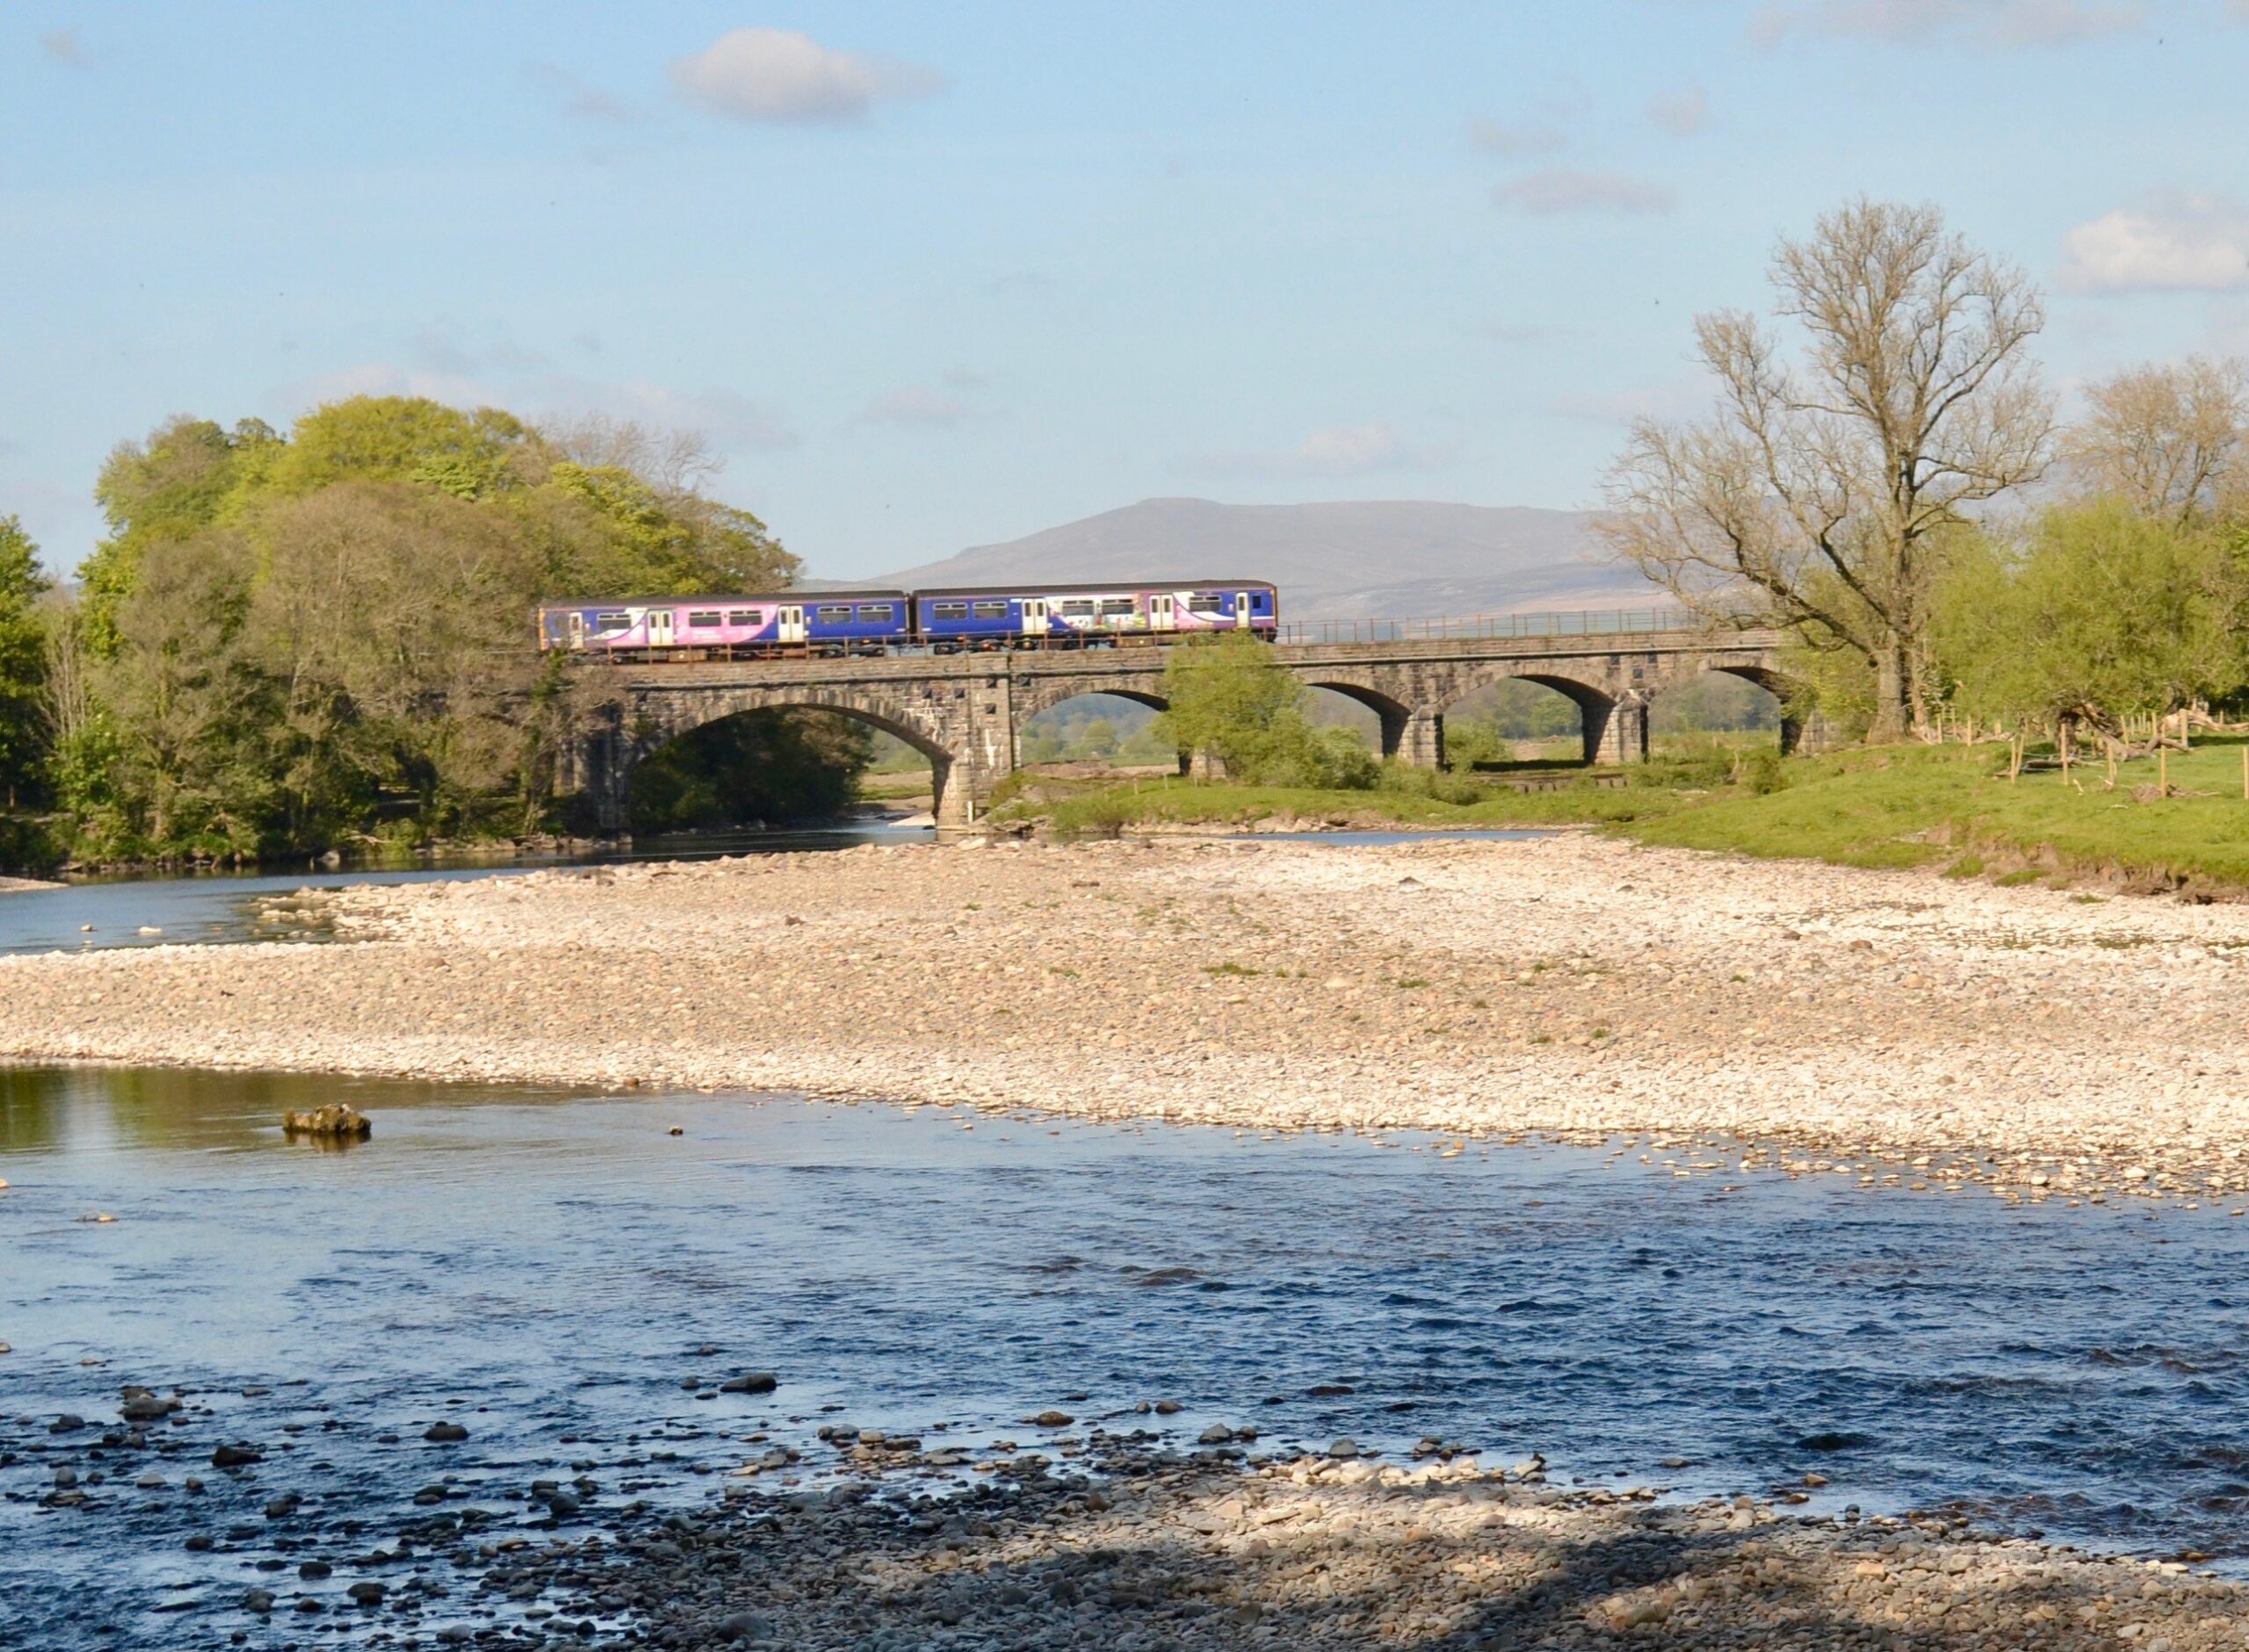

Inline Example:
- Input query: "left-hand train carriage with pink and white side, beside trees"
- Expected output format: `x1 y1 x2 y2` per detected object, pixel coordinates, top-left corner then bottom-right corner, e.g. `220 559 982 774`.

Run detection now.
539 591 913 660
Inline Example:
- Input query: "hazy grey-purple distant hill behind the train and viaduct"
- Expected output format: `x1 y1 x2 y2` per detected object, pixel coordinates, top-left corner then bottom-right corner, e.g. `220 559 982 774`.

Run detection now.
866 499 1660 620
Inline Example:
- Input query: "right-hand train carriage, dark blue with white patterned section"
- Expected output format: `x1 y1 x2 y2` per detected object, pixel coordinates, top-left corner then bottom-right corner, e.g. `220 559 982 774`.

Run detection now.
913 580 1280 652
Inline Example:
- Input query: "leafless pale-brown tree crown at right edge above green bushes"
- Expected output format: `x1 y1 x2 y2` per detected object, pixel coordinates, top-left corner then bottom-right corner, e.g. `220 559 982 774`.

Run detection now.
2063 355 2249 523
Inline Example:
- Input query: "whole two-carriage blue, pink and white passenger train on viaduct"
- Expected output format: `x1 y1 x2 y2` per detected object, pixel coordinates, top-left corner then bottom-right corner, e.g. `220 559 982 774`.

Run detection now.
539 580 1280 660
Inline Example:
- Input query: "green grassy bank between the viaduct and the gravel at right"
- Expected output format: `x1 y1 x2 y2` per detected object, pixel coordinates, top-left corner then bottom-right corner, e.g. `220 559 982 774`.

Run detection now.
996 739 2249 890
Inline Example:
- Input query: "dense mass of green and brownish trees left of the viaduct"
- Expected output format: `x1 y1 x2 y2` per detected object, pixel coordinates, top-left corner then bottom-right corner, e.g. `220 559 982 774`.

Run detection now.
0 395 864 881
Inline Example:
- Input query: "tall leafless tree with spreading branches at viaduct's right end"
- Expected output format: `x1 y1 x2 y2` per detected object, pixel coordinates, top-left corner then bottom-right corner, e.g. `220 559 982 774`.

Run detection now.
1599 200 2053 739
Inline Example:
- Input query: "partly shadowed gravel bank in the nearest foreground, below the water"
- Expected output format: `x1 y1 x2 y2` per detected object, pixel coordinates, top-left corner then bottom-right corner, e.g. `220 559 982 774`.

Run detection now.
531 1430 2249 1652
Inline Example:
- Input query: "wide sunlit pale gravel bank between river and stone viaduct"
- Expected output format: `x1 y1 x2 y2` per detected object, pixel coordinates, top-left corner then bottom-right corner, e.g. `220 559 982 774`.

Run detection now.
0 836 2249 1202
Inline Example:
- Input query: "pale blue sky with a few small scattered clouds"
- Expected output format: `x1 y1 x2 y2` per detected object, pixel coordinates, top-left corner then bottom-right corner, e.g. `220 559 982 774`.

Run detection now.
0 0 2249 575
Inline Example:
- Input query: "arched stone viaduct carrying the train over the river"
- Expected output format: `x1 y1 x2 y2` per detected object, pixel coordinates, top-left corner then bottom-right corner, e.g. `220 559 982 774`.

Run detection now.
560 614 1797 832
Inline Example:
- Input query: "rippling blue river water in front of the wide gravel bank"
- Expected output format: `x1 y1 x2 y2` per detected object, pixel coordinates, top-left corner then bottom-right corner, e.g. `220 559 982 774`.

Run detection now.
0 1068 2249 1648
